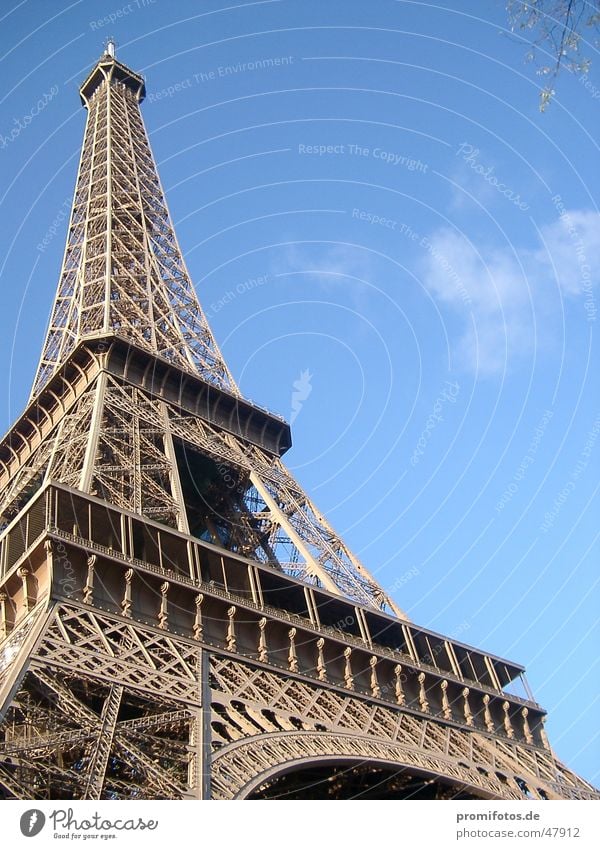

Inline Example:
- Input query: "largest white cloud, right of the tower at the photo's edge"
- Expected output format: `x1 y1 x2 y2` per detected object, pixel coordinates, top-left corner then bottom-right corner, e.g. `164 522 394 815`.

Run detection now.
420 210 600 375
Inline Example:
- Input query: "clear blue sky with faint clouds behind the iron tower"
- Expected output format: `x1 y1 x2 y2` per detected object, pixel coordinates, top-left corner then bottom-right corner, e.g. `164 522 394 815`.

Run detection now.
0 0 600 782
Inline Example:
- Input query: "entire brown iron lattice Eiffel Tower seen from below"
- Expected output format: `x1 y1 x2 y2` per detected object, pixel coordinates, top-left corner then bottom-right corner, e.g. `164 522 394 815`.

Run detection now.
0 43 597 799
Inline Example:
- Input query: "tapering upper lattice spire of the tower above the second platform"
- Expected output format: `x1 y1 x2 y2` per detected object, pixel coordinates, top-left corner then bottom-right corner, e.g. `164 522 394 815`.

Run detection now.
31 46 239 398
